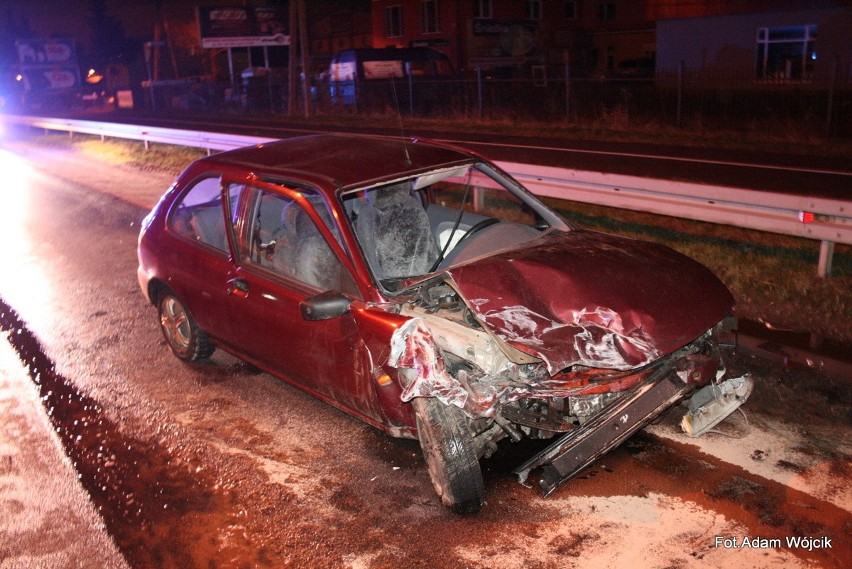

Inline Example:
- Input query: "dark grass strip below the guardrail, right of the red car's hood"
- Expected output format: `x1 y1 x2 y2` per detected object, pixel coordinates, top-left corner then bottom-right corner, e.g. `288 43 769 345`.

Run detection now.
545 200 852 342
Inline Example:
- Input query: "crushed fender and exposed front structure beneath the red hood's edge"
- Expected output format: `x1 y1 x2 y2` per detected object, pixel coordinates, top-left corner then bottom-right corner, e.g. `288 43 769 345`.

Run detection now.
388 296 724 420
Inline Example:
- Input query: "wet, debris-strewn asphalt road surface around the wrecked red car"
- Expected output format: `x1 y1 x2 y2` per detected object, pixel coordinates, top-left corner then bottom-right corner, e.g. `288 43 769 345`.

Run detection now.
0 139 852 568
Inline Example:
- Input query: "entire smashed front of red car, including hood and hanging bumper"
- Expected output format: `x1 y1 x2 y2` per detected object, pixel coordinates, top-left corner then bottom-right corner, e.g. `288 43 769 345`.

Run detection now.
388 229 751 494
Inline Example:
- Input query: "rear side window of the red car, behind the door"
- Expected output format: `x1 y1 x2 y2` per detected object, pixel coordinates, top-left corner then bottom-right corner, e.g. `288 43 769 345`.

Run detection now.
168 178 228 251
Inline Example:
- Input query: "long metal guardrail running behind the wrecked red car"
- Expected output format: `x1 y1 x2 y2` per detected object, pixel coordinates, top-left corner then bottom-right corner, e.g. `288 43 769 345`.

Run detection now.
3 115 852 277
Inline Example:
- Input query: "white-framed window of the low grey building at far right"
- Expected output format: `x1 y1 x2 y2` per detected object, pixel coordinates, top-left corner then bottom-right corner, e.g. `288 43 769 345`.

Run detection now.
756 26 817 81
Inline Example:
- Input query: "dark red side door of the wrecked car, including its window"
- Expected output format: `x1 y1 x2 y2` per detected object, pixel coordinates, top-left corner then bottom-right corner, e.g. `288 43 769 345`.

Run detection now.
225 179 380 421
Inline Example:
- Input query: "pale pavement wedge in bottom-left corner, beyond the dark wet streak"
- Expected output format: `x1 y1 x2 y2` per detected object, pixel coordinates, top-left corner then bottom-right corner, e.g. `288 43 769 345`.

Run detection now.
0 320 126 569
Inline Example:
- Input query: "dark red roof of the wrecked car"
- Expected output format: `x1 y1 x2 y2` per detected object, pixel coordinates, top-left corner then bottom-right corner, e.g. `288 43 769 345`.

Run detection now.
201 134 475 191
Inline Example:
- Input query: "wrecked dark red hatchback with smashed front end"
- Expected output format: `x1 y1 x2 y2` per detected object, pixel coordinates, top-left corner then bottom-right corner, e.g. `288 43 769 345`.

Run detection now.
138 135 751 513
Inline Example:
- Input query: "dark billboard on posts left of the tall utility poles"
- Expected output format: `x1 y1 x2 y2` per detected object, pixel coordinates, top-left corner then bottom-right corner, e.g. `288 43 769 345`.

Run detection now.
198 6 290 48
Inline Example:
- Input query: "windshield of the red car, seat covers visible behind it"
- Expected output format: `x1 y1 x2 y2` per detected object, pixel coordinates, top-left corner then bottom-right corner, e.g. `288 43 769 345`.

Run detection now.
342 162 567 291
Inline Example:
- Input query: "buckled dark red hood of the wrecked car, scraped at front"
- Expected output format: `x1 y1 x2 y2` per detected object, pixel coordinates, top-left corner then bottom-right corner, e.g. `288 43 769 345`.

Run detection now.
447 230 734 374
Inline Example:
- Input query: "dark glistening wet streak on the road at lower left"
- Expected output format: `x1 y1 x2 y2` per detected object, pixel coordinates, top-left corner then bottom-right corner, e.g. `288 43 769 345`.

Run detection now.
0 298 245 567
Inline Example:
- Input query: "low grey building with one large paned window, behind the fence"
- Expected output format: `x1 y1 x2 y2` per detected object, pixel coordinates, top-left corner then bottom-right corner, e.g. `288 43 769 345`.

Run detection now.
656 1 852 88
